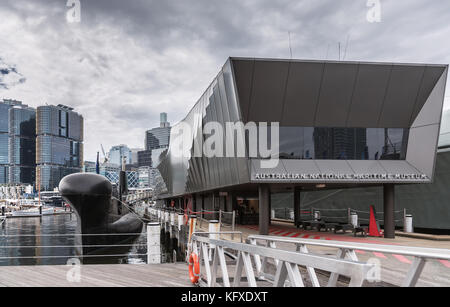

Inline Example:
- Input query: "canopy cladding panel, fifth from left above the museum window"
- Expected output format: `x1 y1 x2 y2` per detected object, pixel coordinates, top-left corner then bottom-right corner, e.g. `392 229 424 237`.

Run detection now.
347 64 392 128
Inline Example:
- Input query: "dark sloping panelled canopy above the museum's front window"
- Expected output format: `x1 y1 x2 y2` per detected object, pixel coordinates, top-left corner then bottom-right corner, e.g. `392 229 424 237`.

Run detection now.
232 58 447 128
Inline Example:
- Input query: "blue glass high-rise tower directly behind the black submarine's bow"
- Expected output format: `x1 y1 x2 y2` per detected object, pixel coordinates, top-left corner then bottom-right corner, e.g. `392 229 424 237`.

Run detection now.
36 105 83 190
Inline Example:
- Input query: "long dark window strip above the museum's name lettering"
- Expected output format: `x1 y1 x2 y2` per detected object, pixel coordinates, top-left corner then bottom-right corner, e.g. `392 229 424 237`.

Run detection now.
280 127 409 160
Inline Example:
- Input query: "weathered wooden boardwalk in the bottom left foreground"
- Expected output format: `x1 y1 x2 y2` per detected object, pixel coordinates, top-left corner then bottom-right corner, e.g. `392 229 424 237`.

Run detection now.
0 263 192 287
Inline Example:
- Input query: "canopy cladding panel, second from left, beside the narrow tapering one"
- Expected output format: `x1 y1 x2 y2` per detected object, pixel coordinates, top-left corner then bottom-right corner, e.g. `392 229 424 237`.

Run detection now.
248 60 289 123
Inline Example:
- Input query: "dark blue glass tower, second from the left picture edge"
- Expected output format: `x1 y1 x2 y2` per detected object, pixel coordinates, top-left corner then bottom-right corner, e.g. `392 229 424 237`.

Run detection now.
9 105 36 185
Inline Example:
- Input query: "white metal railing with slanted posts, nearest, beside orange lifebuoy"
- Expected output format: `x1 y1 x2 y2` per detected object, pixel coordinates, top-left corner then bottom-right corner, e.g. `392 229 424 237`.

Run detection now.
191 234 374 287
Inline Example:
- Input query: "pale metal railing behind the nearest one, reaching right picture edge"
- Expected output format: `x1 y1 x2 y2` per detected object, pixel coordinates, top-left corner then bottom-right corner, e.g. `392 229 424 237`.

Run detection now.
248 235 450 287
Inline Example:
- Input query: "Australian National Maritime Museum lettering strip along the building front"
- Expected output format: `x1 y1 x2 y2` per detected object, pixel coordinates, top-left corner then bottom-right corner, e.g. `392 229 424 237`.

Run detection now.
253 173 430 182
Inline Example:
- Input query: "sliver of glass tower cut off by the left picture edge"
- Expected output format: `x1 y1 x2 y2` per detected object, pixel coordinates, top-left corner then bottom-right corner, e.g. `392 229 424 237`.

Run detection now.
0 99 22 184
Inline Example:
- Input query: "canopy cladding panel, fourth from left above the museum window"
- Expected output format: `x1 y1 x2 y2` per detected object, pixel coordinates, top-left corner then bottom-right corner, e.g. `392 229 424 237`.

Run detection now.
314 63 358 127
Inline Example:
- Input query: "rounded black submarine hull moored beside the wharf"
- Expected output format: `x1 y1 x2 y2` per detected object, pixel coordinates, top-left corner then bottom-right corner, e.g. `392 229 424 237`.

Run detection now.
59 173 143 263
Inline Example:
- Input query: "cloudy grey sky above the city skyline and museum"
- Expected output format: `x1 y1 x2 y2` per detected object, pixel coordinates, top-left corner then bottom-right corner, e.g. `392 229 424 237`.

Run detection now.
0 0 450 160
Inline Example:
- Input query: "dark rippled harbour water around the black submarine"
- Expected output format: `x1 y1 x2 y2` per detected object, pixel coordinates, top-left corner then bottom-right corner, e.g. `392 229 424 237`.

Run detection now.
0 214 151 266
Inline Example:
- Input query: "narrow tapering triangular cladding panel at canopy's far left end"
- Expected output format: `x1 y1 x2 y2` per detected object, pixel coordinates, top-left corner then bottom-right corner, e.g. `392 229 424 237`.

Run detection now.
233 59 255 122
